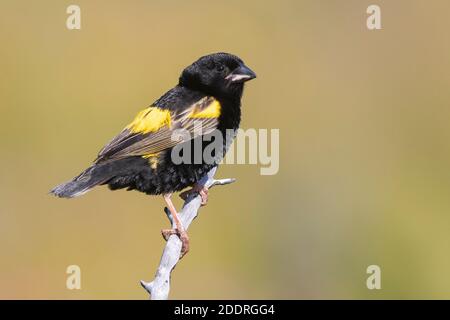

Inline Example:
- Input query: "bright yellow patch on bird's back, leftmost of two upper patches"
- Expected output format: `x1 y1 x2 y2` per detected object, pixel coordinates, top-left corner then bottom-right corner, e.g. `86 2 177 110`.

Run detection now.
126 107 171 134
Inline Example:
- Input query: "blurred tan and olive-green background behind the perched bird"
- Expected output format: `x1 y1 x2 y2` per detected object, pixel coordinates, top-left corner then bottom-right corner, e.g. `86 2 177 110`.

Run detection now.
0 0 450 299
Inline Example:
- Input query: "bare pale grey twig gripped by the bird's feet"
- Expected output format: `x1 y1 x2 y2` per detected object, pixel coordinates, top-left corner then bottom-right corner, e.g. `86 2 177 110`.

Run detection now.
141 167 235 300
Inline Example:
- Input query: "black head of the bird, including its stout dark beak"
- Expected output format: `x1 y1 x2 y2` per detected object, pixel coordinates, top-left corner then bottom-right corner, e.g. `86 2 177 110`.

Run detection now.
180 52 256 98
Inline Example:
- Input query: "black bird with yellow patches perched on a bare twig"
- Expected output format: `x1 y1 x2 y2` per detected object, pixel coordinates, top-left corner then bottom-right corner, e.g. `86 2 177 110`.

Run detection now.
51 53 256 255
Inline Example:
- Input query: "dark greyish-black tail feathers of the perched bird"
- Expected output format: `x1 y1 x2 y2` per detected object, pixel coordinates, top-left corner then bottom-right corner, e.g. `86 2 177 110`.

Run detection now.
50 164 112 198
